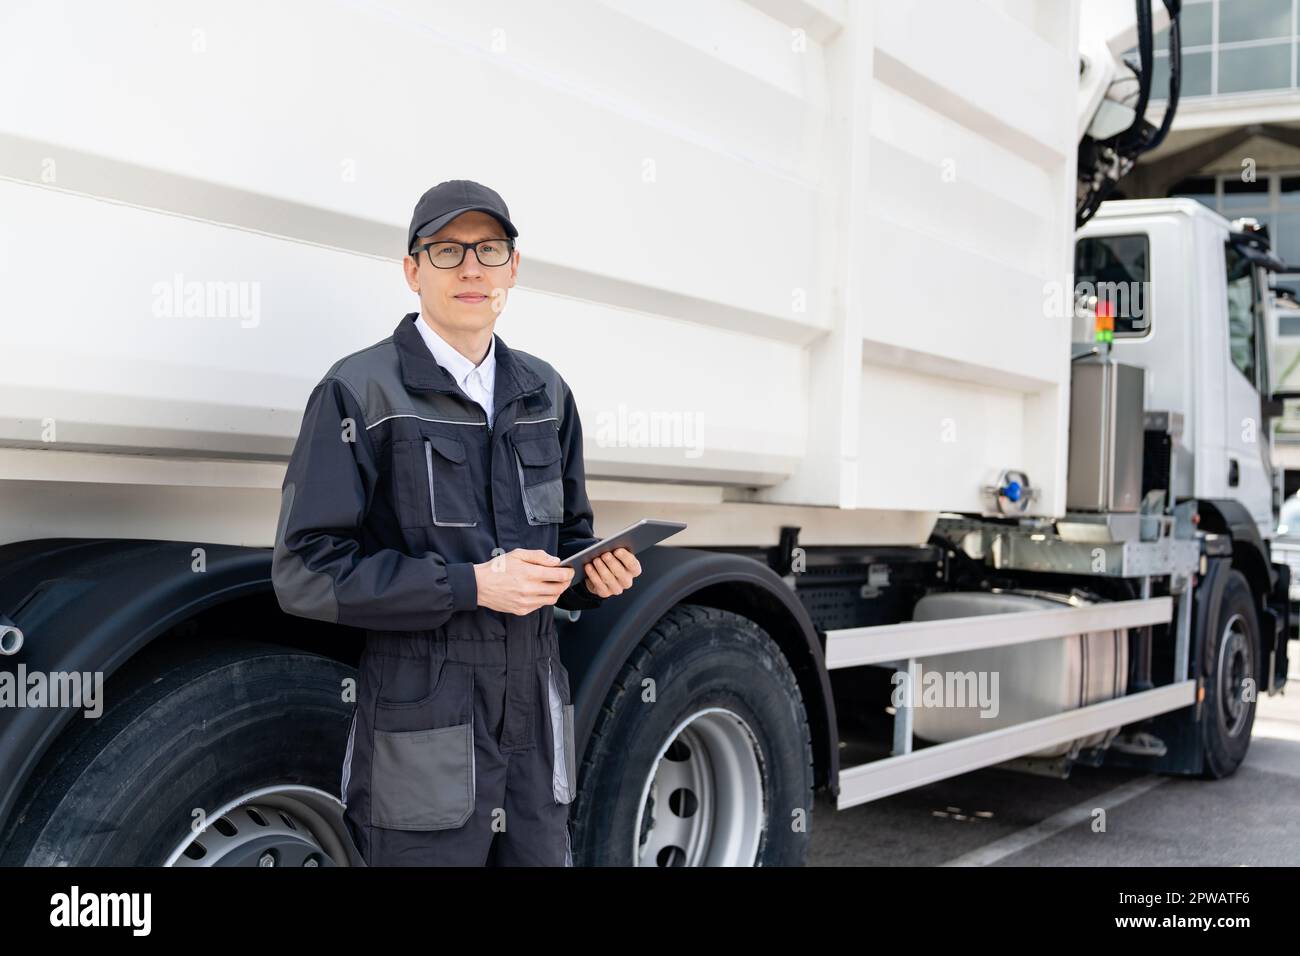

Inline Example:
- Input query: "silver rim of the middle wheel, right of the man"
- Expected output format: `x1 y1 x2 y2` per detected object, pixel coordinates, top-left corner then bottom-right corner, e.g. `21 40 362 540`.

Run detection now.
632 708 766 866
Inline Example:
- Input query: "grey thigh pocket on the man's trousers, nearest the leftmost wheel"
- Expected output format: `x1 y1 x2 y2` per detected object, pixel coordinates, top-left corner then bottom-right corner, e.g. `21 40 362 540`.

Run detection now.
371 663 476 830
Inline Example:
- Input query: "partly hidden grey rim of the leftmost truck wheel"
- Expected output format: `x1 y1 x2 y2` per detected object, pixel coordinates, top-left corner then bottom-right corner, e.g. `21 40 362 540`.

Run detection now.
163 786 352 866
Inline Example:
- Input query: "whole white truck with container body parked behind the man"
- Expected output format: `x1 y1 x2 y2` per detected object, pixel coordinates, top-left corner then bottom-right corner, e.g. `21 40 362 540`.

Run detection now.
0 0 1290 866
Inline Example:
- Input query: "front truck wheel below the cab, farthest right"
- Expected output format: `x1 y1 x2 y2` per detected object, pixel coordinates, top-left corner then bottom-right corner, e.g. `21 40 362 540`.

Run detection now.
1201 571 1260 779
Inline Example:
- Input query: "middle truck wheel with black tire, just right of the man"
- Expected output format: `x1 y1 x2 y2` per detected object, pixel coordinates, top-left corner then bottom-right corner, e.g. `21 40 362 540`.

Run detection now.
572 605 814 866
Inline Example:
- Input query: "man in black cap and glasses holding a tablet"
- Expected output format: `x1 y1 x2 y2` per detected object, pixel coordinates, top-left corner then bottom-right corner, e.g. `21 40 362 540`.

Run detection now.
272 179 641 866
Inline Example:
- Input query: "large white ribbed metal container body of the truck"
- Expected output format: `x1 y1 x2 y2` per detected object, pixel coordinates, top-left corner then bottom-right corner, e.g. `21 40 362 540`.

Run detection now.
0 0 1079 545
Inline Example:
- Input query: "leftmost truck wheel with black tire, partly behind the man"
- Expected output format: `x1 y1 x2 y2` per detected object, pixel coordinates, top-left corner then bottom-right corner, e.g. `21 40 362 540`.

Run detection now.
0 639 360 866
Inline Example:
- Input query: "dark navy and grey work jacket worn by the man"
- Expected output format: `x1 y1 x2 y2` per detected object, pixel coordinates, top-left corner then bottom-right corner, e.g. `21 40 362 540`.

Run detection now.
272 312 602 637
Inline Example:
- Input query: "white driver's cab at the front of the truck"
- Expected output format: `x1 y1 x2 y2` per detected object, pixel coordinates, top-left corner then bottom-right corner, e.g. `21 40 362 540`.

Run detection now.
1073 198 1281 540
